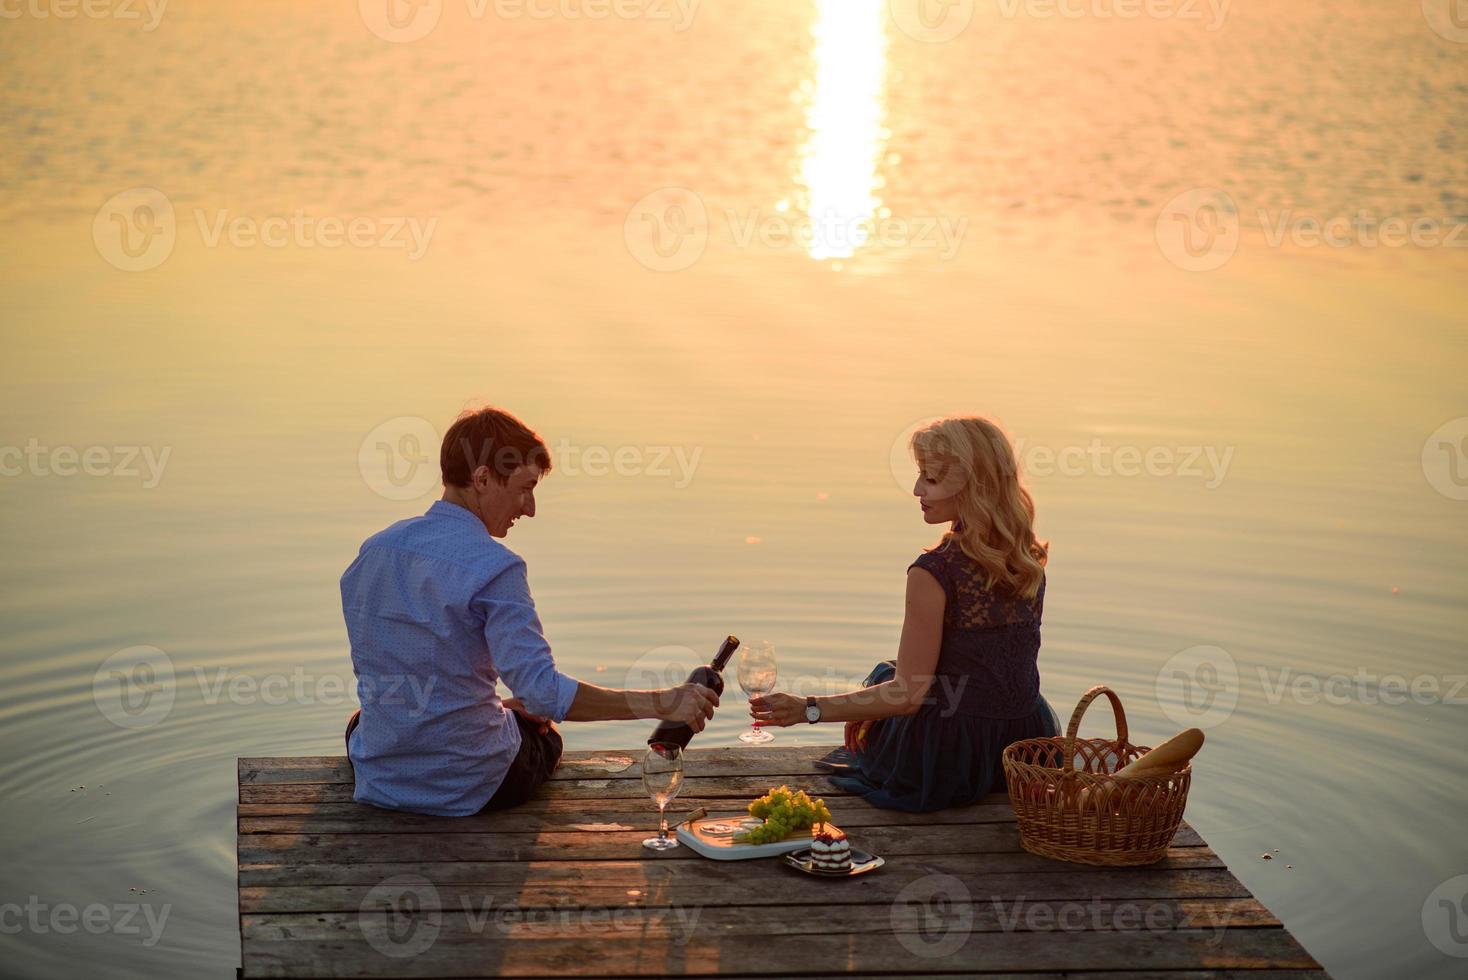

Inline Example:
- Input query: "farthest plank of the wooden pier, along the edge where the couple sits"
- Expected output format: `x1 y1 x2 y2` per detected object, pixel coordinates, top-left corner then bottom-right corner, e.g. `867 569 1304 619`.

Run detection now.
238 745 835 785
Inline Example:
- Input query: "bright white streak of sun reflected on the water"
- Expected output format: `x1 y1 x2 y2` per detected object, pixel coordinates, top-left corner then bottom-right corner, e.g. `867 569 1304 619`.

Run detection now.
800 0 888 260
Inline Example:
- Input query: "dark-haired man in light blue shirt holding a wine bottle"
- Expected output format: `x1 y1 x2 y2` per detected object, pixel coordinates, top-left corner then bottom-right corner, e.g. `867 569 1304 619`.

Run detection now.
342 408 719 817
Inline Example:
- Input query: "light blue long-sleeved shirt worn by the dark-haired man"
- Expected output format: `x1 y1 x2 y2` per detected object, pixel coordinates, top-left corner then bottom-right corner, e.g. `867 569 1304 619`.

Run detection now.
342 500 577 817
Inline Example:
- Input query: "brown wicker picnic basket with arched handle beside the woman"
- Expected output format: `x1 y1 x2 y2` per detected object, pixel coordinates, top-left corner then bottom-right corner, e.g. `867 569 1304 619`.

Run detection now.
1004 685 1192 867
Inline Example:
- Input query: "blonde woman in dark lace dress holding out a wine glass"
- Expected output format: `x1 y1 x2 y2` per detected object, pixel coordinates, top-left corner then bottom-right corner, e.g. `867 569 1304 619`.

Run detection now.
750 418 1060 811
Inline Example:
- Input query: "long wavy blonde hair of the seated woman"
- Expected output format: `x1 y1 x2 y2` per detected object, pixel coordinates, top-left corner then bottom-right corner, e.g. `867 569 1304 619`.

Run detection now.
910 415 1050 599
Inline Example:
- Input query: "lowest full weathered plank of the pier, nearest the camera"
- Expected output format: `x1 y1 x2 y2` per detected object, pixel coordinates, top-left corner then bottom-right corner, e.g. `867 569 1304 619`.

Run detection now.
245 915 1318 977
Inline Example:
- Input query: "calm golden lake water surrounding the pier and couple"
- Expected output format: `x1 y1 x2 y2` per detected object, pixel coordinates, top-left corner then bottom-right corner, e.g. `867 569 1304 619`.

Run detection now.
0 0 1468 980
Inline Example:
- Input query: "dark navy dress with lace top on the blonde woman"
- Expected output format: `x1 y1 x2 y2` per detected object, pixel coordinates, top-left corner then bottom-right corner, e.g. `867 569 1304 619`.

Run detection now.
831 541 1060 811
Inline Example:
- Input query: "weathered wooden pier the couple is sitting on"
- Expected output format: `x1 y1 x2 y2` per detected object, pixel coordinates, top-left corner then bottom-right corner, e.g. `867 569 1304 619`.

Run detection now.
239 742 1326 980
